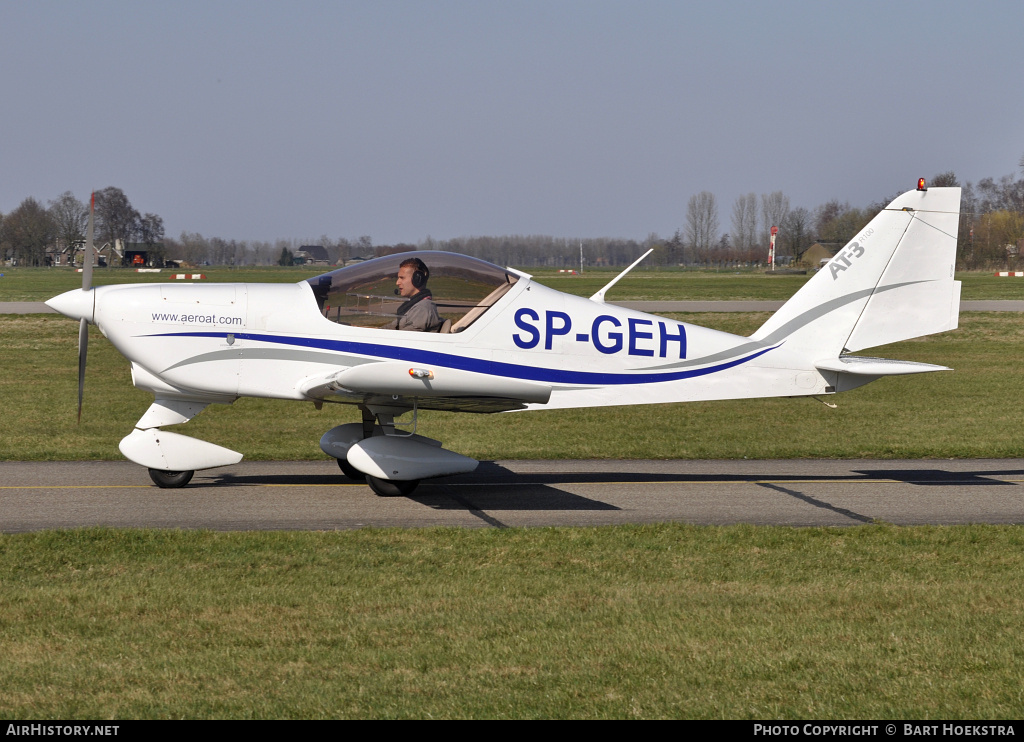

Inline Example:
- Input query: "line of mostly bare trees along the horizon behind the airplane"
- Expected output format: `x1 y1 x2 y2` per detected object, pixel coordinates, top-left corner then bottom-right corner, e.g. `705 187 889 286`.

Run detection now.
0 157 1024 269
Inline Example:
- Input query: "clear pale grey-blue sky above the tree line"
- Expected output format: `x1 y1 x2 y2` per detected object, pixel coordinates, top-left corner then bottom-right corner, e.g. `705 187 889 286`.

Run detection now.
0 0 1024 244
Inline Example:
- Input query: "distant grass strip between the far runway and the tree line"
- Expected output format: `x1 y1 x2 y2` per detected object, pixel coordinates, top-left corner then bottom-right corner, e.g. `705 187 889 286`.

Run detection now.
8 266 1024 302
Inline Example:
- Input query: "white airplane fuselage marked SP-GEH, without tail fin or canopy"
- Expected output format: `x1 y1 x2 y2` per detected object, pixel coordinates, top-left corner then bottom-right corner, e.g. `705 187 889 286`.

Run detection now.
53 276 826 408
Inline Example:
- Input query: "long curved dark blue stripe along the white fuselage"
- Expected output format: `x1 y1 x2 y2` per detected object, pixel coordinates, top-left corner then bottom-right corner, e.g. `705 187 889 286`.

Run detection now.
145 333 781 385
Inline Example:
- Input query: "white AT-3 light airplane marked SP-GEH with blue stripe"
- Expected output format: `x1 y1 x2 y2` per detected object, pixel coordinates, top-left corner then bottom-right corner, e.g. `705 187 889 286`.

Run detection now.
46 180 961 496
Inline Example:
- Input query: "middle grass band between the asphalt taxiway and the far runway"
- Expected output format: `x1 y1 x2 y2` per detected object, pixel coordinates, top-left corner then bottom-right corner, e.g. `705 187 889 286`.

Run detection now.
0 312 1024 461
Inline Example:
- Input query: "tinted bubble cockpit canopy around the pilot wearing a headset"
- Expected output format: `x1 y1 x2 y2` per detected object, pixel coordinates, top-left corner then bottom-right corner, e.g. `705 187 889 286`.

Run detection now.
306 251 519 333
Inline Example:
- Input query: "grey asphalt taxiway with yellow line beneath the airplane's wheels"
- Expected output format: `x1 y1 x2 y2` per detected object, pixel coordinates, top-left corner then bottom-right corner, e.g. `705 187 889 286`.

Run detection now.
0 459 1024 533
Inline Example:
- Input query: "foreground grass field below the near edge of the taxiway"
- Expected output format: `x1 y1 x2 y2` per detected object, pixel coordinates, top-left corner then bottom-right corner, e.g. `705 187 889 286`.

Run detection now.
0 524 1024 719
